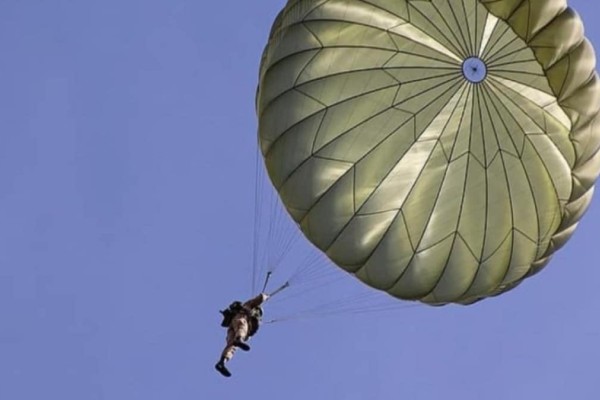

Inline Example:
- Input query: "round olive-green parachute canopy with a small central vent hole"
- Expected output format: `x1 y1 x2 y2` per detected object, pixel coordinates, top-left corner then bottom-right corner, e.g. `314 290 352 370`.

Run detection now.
256 0 600 305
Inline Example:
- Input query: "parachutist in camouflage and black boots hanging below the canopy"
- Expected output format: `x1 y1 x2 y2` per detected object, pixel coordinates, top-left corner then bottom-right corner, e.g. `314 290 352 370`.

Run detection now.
215 293 269 377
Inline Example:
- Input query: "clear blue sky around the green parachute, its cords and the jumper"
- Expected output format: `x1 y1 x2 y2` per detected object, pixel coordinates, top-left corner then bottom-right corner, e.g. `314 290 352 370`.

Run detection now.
0 0 600 400
